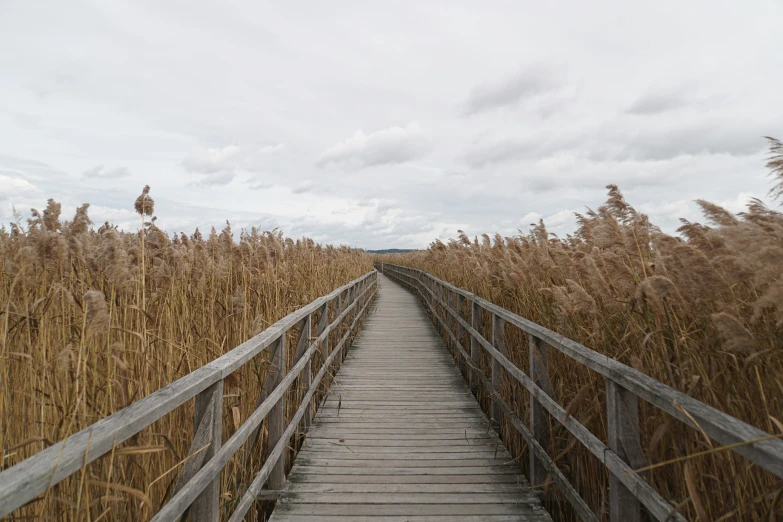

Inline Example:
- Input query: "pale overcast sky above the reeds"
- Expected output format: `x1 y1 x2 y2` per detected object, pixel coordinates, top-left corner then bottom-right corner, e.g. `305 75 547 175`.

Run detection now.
0 0 783 248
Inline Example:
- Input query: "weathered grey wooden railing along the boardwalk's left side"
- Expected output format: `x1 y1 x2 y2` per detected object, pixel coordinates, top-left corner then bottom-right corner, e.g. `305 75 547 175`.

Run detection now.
0 270 378 522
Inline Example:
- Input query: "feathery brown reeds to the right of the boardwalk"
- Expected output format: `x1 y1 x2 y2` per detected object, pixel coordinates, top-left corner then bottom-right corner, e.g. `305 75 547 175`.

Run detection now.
376 139 783 522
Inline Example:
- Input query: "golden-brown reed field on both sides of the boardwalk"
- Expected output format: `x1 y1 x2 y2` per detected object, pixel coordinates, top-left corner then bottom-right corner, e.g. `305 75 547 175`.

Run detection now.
0 141 783 522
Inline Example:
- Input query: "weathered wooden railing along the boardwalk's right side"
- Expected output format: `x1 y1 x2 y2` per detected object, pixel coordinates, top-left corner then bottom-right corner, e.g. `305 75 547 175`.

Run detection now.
376 263 783 522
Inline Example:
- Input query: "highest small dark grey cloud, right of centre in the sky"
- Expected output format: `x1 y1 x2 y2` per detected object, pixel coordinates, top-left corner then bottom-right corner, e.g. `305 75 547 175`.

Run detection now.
463 65 562 115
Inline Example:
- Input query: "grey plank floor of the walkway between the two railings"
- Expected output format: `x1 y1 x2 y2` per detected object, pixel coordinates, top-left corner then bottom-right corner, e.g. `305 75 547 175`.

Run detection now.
271 275 551 522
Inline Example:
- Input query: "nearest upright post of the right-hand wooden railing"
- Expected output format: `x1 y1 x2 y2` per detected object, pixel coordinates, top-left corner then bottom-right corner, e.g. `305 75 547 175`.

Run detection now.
606 379 646 522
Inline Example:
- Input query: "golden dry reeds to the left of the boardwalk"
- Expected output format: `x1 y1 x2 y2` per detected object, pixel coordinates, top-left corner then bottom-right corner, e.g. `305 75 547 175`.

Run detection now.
0 187 372 521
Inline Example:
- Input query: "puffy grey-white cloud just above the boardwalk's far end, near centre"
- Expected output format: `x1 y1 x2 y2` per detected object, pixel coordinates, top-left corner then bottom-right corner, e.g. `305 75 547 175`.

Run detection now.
317 122 432 168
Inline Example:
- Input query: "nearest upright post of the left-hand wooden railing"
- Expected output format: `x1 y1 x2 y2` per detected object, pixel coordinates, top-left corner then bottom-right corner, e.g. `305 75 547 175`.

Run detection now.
190 380 223 522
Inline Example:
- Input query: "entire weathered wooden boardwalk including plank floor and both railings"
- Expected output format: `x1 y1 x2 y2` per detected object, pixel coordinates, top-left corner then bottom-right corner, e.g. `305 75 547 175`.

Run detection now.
0 263 783 522
